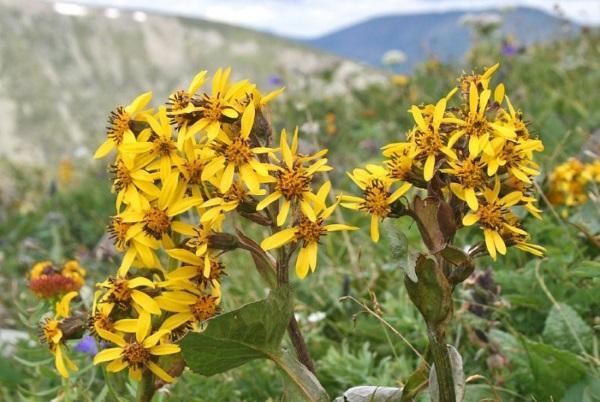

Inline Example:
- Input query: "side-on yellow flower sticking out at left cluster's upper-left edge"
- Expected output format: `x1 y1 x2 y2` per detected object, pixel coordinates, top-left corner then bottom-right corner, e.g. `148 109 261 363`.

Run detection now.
94 92 152 159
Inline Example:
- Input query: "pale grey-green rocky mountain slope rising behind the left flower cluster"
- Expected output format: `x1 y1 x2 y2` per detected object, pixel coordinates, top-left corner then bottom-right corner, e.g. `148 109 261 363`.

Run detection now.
0 0 372 165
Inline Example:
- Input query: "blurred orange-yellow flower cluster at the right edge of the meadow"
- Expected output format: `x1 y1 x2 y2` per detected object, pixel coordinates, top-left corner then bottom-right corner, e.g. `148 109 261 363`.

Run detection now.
548 158 600 207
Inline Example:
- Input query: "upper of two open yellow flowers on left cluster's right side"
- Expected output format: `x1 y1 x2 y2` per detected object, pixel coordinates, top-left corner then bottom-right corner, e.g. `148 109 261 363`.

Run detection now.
256 128 332 226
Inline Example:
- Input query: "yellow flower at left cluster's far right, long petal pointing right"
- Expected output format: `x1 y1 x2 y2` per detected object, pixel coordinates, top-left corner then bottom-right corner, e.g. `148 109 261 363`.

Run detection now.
260 182 358 279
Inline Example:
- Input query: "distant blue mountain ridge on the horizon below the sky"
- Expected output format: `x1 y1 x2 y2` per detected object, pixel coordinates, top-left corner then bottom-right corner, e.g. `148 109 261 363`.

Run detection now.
306 7 575 71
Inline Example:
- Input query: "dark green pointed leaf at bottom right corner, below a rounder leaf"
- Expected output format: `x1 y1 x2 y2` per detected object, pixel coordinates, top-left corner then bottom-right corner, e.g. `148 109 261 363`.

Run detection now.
521 338 586 401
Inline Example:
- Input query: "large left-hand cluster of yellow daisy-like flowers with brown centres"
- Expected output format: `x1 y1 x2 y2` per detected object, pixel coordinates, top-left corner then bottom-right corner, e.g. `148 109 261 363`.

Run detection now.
89 69 351 382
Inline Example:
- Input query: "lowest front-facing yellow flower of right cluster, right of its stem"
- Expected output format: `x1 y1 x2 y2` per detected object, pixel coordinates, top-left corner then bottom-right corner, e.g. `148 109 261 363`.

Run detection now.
462 180 527 260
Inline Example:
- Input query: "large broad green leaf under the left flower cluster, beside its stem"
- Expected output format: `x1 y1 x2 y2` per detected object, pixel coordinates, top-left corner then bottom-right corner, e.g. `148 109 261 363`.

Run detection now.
181 287 292 376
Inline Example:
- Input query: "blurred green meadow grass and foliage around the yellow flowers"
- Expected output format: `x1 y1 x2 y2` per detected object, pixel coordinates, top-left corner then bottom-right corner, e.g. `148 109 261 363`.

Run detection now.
0 32 600 401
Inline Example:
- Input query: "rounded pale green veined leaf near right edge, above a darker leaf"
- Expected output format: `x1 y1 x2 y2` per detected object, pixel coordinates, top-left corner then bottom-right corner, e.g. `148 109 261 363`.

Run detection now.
543 303 594 353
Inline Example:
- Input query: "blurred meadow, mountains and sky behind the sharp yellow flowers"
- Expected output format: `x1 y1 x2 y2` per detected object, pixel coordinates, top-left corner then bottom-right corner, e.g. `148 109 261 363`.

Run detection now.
0 0 600 401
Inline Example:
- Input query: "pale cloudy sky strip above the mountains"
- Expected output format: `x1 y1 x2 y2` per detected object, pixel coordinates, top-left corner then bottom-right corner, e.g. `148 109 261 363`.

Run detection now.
50 0 600 38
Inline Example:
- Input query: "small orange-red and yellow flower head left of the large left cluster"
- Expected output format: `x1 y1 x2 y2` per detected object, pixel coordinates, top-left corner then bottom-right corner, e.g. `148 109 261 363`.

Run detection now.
29 260 85 299
